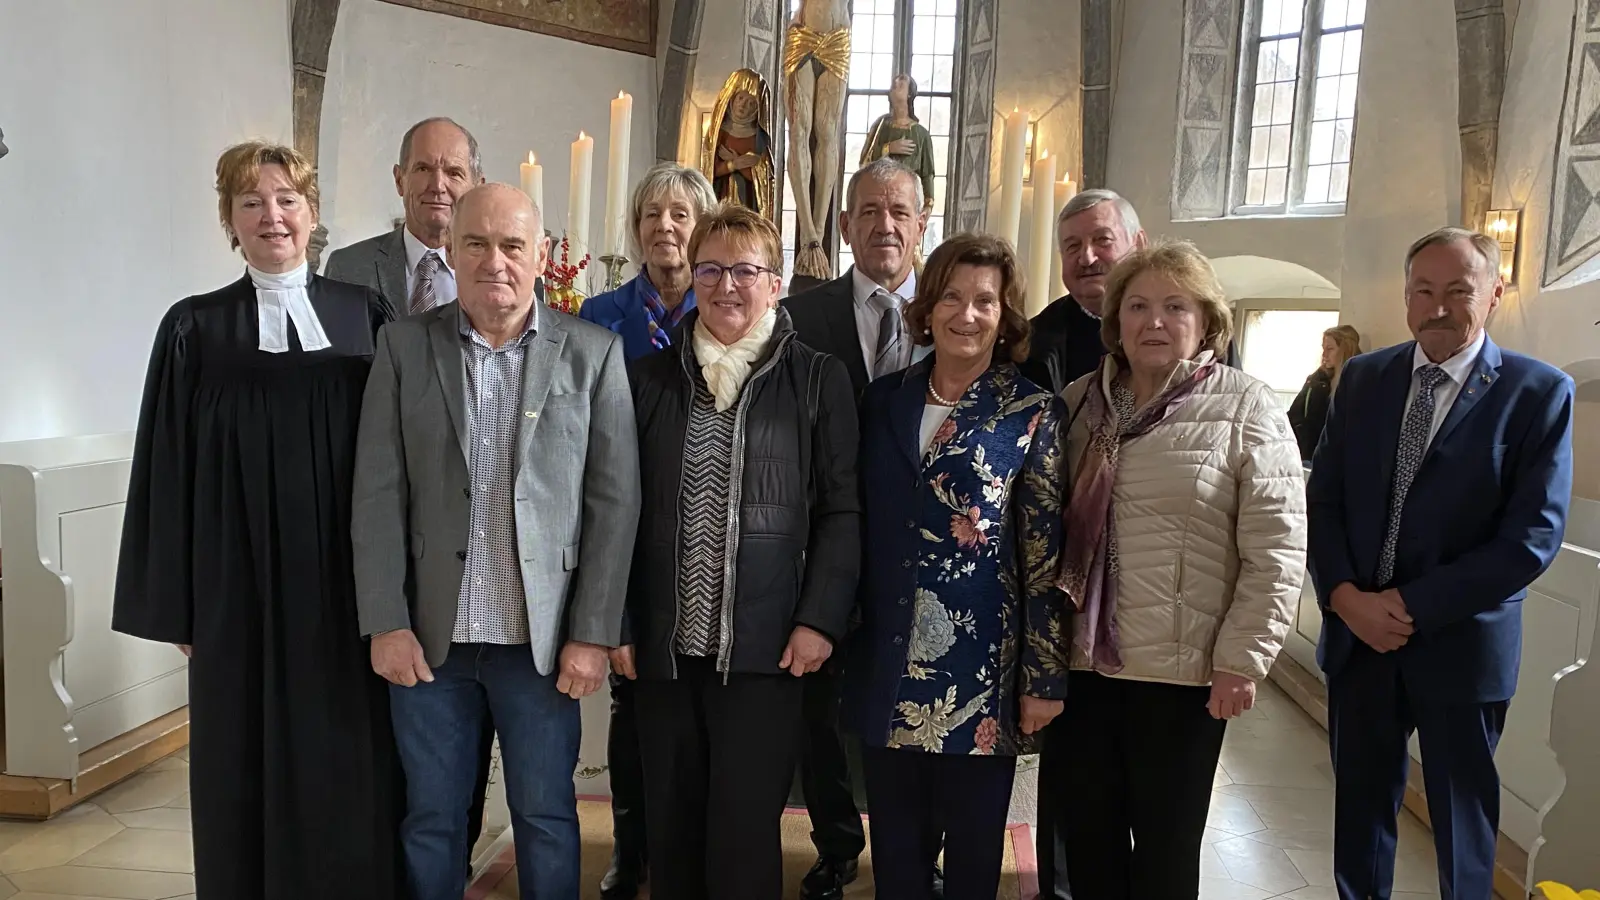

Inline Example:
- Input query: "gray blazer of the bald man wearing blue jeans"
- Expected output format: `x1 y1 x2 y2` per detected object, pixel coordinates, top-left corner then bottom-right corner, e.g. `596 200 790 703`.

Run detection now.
352 303 640 674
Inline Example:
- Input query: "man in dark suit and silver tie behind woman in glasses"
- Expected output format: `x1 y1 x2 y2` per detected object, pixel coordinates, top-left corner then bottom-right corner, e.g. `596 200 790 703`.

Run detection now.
784 159 928 900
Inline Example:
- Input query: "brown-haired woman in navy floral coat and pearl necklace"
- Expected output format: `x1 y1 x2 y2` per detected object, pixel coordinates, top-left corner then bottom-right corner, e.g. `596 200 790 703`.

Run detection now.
843 235 1069 900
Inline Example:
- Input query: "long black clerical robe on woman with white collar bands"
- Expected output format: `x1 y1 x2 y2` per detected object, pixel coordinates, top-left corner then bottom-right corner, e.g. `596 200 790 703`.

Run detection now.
112 277 405 900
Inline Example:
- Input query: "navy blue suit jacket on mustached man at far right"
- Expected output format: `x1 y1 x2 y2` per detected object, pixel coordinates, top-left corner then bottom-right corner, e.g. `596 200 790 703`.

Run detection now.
1307 338 1573 703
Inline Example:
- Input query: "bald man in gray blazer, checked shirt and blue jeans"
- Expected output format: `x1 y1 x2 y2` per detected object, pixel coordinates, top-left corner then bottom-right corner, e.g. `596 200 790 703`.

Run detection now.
352 184 640 900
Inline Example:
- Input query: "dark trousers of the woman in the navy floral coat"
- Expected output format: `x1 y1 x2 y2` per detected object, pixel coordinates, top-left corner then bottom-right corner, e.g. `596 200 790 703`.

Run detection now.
861 748 1016 900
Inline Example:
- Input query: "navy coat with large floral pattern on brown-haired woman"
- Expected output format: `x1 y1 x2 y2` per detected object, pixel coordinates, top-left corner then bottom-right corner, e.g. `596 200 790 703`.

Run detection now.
843 360 1070 754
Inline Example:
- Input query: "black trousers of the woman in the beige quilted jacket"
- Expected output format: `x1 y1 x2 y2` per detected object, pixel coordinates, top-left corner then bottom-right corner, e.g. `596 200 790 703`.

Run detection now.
1050 673 1227 900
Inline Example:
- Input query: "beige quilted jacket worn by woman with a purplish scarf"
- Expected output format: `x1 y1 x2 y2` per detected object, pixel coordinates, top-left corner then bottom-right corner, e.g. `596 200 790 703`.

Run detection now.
1062 357 1306 685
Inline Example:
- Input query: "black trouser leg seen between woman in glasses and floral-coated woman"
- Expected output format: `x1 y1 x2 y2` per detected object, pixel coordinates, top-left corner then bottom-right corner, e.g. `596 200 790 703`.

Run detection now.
800 666 867 862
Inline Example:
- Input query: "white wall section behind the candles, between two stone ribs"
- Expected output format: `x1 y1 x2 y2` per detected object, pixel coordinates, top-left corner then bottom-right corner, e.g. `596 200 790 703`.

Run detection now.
322 0 659 266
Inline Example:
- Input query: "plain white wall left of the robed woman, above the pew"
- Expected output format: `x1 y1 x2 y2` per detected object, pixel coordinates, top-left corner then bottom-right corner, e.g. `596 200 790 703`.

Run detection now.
0 0 293 442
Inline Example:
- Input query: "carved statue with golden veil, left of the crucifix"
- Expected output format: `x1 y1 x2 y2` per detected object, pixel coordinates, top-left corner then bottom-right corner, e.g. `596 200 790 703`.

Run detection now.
701 69 778 219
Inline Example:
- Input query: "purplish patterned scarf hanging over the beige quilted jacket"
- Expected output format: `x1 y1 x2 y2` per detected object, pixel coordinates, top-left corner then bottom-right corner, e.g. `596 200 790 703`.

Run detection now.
1056 356 1216 674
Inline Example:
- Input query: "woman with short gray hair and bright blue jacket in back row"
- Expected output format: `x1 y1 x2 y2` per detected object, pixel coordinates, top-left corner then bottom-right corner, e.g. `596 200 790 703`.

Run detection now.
578 162 717 362
